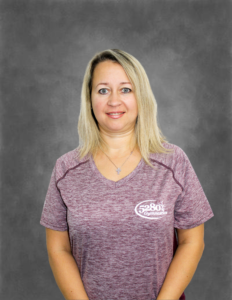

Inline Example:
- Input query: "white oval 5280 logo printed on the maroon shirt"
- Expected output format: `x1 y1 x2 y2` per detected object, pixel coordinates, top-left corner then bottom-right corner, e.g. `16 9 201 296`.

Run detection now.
135 200 167 219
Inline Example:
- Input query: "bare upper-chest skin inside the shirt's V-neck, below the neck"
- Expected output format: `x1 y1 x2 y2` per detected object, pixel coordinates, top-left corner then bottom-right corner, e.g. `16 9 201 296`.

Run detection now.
94 149 142 182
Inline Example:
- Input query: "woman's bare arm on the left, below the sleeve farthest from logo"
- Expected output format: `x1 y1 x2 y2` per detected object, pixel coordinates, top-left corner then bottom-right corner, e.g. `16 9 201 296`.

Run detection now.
46 228 89 300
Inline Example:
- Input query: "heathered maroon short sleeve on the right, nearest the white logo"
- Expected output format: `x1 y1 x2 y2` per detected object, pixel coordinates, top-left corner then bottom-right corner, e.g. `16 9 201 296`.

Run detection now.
174 150 214 229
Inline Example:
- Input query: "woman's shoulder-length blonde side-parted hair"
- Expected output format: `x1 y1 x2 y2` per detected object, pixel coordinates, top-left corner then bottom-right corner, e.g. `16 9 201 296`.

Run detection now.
77 49 172 167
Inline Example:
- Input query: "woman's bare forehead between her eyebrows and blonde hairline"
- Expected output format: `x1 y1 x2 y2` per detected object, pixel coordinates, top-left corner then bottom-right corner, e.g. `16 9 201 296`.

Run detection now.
93 60 129 82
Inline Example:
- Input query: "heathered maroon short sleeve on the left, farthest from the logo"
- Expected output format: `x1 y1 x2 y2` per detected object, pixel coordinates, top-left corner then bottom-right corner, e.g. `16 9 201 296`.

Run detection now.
40 163 68 231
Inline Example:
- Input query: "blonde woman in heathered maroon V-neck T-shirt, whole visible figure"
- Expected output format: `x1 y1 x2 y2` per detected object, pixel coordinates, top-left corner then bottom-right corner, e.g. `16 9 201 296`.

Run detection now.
40 49 213 300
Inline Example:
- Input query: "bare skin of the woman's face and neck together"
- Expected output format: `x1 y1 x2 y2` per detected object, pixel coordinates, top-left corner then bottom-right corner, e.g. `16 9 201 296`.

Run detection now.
91 61 138 158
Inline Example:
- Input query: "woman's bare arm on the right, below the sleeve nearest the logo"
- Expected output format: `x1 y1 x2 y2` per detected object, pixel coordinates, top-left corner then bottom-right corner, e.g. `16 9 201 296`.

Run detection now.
156 223 205 300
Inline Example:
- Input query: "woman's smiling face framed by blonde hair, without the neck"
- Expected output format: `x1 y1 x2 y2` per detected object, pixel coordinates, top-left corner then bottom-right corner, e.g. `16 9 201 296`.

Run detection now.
91 60 138 132
